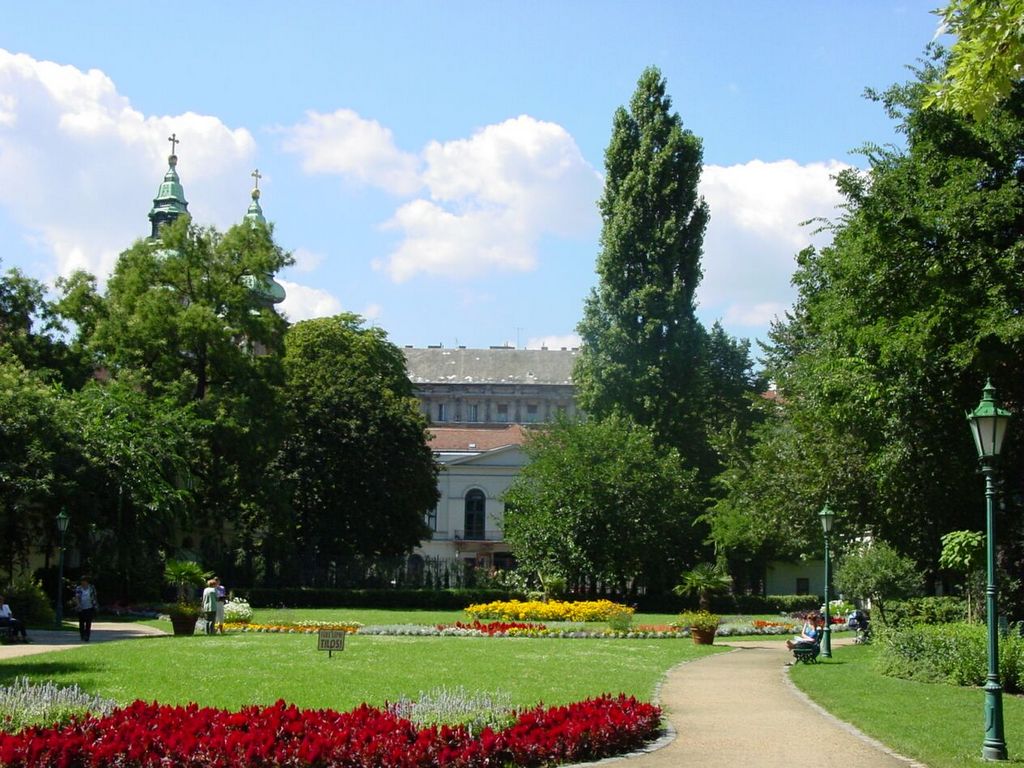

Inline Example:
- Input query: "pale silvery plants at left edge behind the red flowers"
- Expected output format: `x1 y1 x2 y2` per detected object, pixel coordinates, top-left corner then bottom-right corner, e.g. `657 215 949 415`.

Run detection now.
0 677 117 733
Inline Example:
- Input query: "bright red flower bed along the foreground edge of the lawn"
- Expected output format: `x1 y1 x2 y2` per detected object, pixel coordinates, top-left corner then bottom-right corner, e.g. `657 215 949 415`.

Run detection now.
0 694 662 768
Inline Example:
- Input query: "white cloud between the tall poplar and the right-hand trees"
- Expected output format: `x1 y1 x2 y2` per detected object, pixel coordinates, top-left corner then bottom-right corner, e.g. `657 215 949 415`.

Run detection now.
697 160 847 333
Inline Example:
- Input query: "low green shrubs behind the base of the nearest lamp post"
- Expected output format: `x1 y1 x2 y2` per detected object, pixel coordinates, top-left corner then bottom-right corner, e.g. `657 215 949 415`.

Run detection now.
877 624 1024 693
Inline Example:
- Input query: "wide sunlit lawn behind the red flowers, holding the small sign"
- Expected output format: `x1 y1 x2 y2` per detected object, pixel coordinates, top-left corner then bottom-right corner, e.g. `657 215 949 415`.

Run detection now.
0 634 722 710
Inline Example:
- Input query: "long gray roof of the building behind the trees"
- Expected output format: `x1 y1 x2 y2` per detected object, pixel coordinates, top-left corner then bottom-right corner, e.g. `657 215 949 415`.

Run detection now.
403 347 580 385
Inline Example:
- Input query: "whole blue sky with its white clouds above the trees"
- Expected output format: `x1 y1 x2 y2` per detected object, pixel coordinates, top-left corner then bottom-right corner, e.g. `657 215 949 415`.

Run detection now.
0 0 938 347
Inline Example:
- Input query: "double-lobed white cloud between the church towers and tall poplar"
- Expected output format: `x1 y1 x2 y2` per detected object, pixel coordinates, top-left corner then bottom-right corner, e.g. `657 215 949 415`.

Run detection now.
285 110 601 283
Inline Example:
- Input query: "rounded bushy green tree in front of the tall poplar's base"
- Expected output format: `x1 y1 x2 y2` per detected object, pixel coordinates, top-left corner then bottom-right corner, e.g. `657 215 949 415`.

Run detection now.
504 415 699 594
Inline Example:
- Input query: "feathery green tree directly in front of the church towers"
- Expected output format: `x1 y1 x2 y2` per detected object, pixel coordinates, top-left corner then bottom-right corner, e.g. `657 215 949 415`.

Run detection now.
86 216 291 570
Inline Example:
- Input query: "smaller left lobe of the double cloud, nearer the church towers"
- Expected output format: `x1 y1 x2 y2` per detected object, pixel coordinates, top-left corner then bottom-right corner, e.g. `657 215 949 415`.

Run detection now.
284 110 420 195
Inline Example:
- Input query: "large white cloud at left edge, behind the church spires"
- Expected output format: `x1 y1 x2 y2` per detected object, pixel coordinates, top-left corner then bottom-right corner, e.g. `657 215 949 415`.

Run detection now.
0 49 255 281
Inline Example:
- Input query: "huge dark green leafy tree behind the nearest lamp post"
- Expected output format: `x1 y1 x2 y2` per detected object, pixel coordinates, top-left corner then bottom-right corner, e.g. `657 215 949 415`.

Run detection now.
713 55 1024 593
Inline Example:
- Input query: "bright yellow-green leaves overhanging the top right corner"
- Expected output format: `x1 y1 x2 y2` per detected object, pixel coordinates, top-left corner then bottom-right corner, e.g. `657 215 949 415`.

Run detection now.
925 0 1024 120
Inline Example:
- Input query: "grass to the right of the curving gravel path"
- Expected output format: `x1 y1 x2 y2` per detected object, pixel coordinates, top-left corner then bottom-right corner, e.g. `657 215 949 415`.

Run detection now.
791 645 1024 768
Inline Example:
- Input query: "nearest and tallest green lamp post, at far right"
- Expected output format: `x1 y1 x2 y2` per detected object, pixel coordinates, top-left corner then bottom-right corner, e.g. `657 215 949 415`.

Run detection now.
967 381 1010 760
